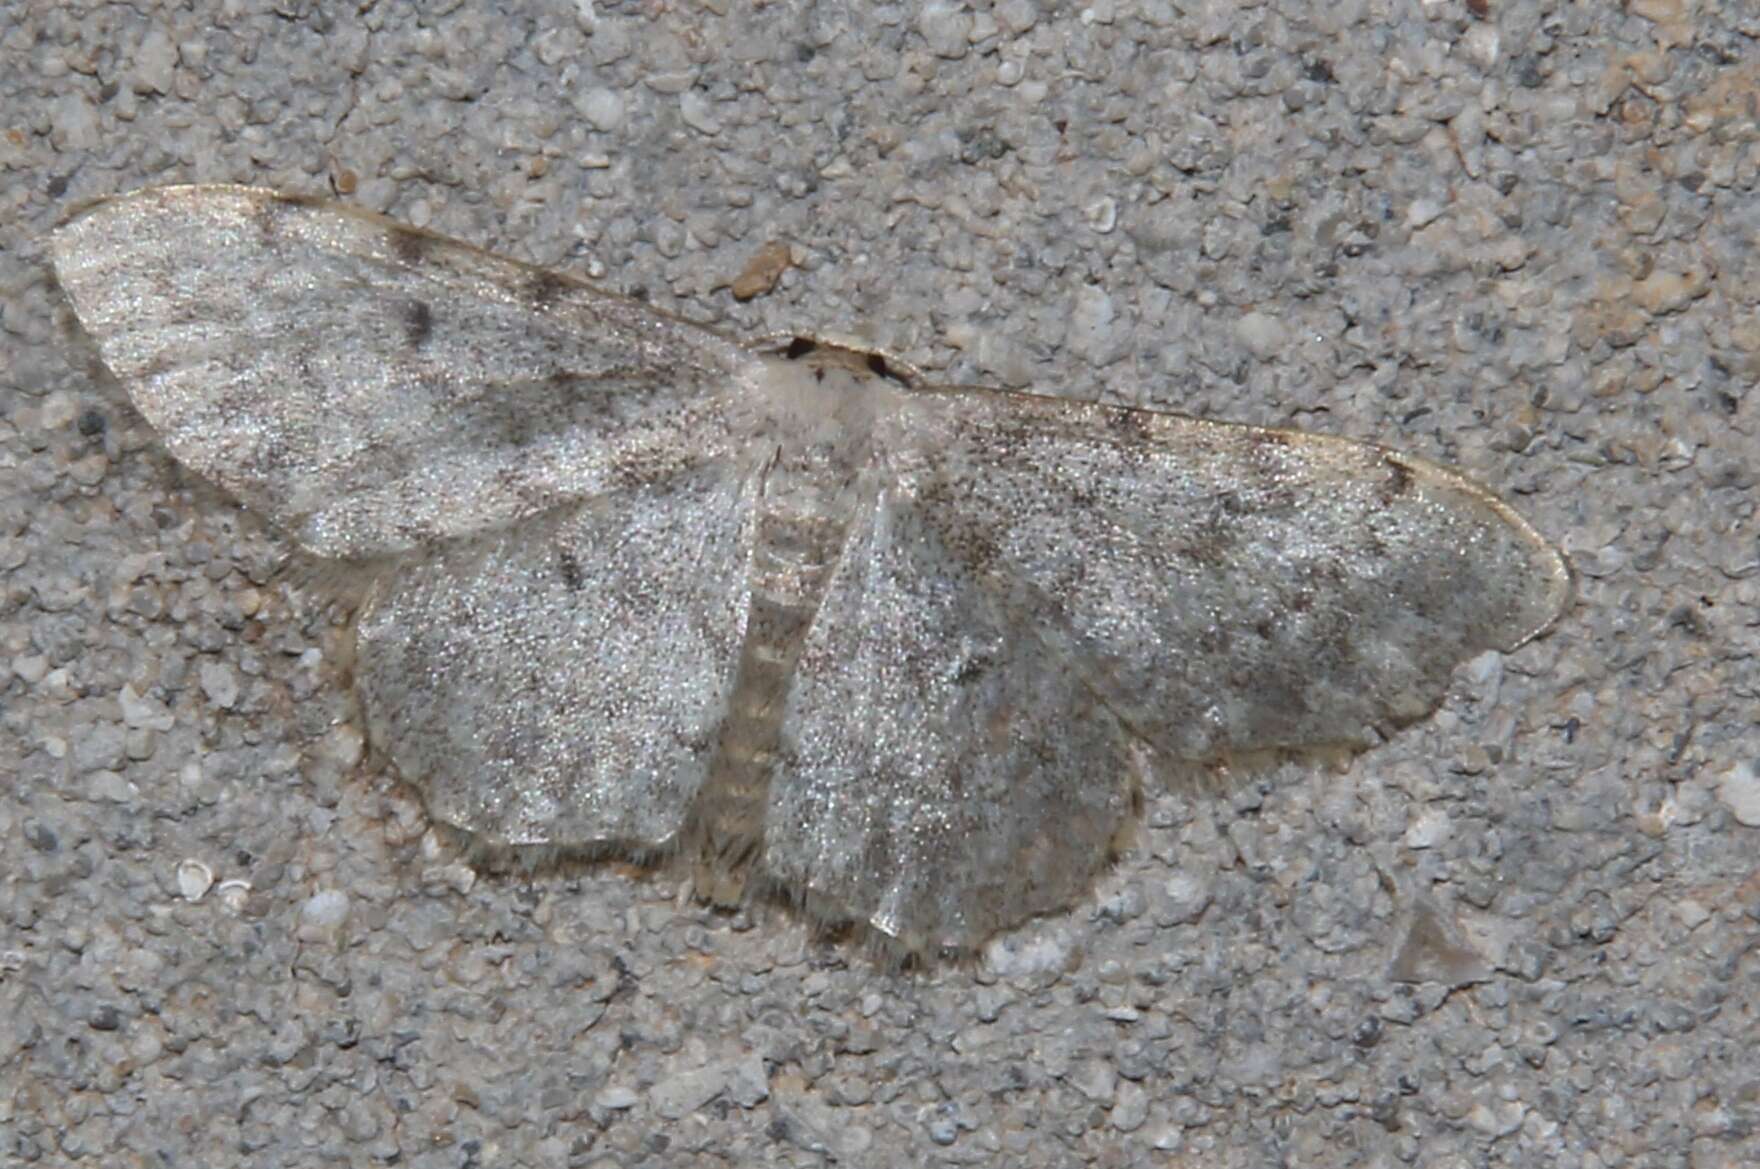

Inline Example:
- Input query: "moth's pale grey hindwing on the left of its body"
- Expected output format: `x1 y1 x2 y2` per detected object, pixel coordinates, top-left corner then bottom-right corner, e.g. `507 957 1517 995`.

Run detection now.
356 468 752 852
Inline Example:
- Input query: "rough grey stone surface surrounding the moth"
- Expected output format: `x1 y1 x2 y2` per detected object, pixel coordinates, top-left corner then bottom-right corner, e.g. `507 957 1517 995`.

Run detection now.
0 0 1760 1167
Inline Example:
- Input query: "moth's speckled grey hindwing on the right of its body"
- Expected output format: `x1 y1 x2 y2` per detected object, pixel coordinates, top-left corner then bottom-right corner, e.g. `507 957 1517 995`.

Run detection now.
764 484 1148 951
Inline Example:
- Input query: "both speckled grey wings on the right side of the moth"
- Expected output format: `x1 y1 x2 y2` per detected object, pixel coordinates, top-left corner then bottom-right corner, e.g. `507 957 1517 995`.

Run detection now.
766 387 1570 949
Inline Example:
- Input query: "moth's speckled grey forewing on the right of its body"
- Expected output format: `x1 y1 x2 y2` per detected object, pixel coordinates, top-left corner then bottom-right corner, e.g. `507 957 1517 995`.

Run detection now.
894 389 1570 762
